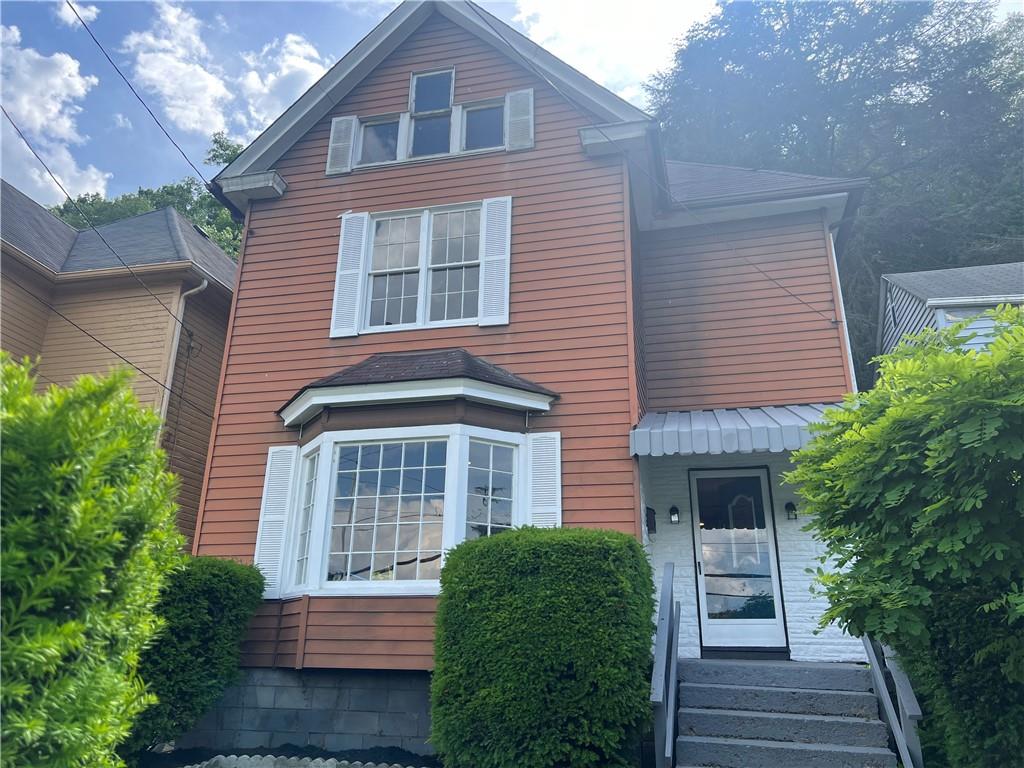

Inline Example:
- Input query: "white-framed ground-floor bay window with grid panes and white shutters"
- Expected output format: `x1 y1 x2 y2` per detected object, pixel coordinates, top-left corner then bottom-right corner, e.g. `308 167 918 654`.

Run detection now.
250 424 561 597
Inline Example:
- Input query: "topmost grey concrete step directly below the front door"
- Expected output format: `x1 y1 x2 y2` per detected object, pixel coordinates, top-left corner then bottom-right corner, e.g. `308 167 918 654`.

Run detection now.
679 658 871 691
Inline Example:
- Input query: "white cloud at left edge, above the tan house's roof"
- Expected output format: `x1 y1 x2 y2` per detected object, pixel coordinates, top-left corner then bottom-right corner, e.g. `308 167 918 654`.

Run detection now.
0 26 111 203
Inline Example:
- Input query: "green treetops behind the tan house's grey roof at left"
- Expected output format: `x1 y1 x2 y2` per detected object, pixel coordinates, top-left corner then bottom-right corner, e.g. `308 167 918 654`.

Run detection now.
50 132 243 258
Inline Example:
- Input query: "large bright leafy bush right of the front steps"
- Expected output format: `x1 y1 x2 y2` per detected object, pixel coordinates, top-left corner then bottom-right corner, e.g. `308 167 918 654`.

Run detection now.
788 308 1024 768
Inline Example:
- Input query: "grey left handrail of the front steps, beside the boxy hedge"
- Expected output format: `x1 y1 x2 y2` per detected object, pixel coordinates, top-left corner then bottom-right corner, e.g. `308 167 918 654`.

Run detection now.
650 562 679 768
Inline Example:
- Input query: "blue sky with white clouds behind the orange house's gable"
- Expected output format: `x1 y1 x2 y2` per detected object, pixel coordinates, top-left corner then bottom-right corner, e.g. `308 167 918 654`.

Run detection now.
0 0 1016 204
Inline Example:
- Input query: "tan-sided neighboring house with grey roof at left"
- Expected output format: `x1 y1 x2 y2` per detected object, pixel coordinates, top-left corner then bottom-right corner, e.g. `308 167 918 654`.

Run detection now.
0 181 236 542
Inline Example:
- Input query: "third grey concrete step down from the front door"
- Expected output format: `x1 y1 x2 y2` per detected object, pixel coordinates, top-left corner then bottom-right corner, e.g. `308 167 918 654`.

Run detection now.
679 708 889 746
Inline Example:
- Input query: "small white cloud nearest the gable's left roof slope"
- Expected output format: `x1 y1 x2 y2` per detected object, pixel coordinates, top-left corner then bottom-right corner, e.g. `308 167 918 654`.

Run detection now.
237 34 328 138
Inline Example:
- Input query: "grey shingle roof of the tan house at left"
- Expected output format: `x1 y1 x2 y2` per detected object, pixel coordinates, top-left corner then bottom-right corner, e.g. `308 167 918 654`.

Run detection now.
0 181 237 290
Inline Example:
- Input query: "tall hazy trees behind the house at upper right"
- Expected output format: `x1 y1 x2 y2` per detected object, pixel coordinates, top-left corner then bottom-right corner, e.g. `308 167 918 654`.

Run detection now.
648 0 1024 381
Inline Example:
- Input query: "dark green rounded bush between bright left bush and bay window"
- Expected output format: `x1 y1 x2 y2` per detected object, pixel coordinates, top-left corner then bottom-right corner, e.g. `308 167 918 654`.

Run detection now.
123 557 263 753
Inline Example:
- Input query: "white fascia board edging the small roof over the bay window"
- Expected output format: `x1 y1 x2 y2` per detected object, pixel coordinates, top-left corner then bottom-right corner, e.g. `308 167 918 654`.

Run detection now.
281 378 554 427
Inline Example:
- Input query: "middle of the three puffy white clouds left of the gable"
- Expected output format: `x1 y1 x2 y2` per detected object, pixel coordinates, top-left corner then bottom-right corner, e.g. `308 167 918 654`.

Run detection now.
122 0 232 135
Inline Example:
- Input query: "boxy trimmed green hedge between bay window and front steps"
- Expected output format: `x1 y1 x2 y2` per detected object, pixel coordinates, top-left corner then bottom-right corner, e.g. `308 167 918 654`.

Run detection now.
431 528 653 768
